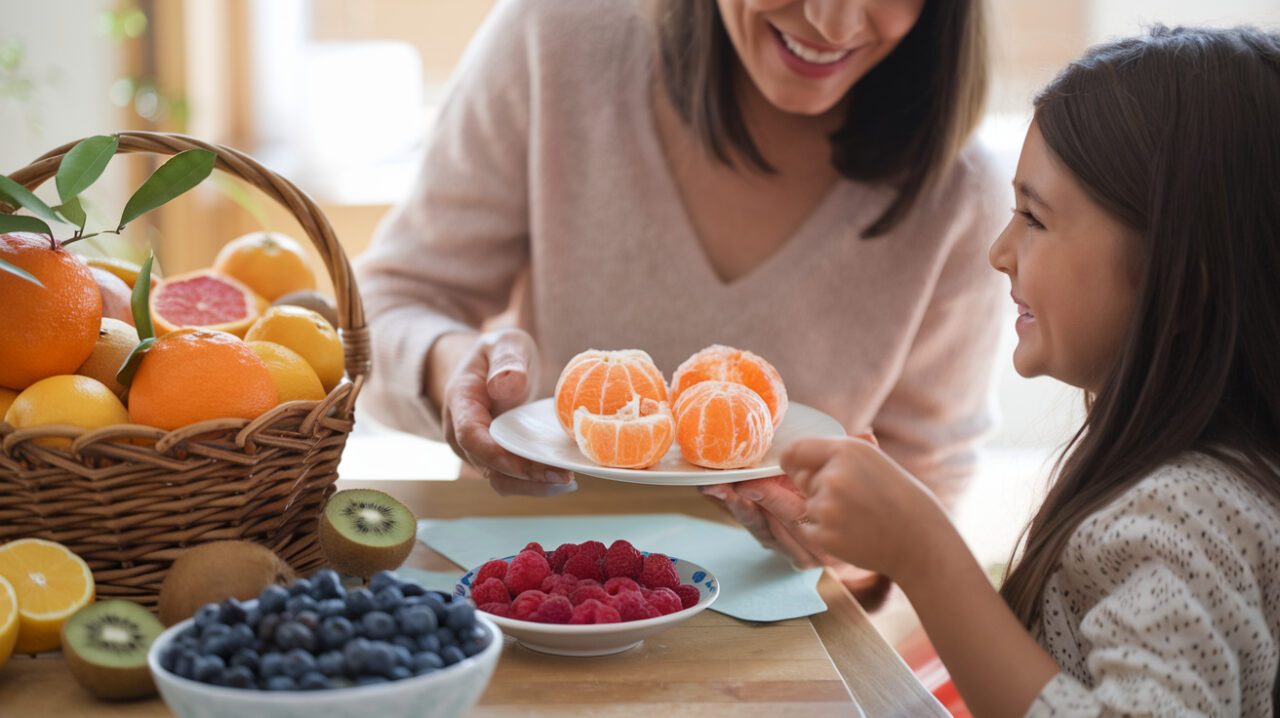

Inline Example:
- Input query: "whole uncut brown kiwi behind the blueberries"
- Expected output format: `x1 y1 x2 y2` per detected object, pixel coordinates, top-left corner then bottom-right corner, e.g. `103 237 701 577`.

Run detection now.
159 541 294 626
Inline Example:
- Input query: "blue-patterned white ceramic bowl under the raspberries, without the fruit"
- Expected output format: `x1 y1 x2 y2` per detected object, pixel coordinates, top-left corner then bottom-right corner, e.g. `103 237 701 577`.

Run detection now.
453 555 719 655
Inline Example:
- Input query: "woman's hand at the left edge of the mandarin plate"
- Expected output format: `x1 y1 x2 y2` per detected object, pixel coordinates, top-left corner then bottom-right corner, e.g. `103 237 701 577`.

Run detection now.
428 329 577 495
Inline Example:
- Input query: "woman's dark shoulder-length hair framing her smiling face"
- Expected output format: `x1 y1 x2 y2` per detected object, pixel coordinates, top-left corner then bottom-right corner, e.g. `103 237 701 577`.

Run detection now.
658 0 988 238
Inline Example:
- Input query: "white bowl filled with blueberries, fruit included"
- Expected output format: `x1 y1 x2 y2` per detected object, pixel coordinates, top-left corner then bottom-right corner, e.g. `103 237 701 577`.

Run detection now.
147 570 502 718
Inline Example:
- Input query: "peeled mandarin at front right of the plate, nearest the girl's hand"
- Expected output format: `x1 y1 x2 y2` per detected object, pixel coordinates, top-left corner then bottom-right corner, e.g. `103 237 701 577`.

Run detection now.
673 380 773 468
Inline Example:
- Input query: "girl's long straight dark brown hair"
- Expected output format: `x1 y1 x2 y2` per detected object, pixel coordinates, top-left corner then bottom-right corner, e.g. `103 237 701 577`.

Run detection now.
1001 27 1280 627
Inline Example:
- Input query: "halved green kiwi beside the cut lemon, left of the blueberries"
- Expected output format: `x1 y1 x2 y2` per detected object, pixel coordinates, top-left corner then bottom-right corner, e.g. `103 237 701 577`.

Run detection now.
63 599 164 700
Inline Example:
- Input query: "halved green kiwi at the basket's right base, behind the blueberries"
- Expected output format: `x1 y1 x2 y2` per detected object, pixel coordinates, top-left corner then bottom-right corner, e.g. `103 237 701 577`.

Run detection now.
320 489 417 578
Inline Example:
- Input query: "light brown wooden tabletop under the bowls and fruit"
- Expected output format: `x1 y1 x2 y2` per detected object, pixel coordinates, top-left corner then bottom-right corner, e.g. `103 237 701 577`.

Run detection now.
0 477 947 718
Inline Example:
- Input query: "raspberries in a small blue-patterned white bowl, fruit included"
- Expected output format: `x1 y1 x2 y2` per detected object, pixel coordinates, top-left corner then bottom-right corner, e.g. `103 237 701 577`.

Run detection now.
453 540 719 655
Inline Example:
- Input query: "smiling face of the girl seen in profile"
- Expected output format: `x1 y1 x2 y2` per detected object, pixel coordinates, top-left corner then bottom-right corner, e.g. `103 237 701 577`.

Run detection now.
991 122 1140 392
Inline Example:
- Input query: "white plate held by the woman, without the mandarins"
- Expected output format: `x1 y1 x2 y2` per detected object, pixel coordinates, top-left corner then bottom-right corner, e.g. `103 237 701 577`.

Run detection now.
489 398 846 486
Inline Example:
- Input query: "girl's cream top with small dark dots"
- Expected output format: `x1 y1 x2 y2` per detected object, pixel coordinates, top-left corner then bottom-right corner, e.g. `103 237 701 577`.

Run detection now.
1028 454 1280 718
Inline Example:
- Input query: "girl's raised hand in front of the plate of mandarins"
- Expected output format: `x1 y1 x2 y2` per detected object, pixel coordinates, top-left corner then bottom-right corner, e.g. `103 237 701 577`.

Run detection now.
782 430 950 582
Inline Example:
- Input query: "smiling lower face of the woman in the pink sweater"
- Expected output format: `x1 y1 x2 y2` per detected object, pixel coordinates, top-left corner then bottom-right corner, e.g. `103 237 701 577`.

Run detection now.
716 0 926 115
